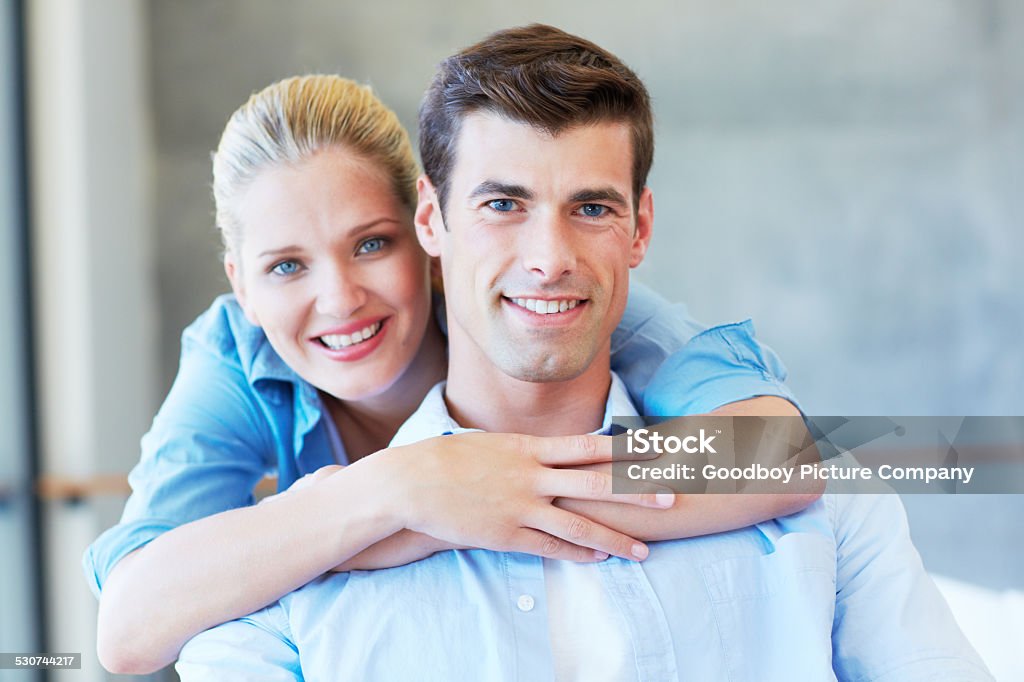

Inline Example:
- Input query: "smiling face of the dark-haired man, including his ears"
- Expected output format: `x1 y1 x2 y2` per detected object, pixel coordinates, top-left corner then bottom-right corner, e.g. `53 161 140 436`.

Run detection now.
417 113 653 382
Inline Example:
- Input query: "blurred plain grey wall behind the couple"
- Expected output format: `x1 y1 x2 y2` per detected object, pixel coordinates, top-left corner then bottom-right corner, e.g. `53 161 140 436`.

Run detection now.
148 0 1024 587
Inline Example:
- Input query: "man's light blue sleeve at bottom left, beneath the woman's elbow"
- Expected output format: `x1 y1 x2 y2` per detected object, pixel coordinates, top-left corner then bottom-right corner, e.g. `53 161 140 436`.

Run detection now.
175 604 303 682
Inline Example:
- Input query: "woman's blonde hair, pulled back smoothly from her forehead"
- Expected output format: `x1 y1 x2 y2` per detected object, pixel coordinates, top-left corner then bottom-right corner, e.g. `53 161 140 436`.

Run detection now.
213 75 419 251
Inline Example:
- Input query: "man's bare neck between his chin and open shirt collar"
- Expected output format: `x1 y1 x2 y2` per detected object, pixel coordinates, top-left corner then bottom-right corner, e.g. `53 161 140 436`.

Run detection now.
444 333 611 435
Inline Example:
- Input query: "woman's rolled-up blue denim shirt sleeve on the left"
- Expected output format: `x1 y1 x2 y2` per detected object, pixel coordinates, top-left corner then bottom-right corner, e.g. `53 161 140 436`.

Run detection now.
83 344 272 597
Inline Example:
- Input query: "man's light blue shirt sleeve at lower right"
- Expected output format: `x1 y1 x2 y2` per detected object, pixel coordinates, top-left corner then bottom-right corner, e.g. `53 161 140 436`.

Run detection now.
826 485 993 682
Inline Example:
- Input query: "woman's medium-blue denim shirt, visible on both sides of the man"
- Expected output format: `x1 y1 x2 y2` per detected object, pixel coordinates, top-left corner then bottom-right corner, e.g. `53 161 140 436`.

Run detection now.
83 282 793 595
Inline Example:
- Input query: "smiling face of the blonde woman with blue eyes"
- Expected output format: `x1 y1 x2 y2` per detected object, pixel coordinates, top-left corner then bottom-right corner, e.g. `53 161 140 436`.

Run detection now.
224 147 430 400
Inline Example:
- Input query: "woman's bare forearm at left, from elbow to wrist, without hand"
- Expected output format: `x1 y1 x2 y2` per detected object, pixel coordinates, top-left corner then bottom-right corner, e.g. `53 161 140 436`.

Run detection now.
97 454 401 674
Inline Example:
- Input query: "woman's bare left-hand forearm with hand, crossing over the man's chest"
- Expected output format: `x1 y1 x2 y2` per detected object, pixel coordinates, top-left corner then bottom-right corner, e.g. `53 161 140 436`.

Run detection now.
98 433 667 674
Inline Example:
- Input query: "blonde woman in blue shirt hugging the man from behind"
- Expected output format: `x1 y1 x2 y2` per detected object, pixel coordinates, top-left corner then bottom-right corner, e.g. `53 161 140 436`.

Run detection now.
85 76 813 673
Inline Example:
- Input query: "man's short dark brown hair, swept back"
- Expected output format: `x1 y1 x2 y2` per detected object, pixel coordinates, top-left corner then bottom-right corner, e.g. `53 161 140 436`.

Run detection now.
420 24 654 211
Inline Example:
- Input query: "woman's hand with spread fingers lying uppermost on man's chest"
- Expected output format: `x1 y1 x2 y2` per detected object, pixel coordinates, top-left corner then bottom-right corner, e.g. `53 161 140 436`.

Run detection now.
372 432 675 568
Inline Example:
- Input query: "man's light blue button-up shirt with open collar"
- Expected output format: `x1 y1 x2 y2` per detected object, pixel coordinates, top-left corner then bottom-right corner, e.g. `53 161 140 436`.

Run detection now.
177 374 991 682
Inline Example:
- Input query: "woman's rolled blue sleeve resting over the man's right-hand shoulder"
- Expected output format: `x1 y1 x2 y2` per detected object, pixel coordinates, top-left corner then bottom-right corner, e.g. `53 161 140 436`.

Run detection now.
643 319 799 417
